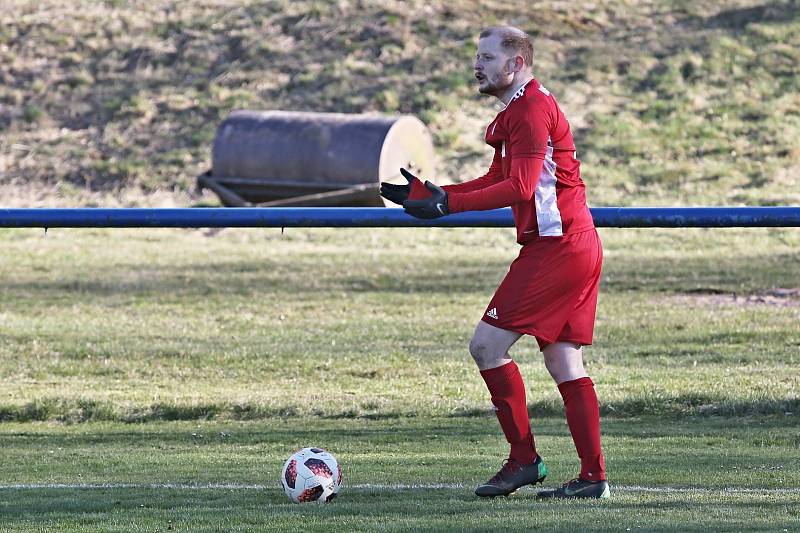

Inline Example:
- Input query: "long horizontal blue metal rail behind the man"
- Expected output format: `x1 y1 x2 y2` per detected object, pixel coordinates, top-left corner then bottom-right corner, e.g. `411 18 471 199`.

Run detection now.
0 206 800 228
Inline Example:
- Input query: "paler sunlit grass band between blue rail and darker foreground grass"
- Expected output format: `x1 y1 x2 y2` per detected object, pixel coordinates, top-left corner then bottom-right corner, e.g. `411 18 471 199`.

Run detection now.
0 230 800 421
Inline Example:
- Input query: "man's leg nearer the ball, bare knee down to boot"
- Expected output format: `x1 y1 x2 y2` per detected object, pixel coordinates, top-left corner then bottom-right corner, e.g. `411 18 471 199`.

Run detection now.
469 322 547 497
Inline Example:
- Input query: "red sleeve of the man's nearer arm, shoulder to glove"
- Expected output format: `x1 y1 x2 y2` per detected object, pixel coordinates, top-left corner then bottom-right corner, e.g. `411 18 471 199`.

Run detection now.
448 105 550 213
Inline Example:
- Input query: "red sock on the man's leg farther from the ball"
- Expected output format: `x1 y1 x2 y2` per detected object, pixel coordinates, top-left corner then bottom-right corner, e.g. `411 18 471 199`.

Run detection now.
558 377 606 481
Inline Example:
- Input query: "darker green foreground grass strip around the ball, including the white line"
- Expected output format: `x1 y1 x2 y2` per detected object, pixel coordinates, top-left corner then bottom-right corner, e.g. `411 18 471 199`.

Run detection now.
0 417 800 531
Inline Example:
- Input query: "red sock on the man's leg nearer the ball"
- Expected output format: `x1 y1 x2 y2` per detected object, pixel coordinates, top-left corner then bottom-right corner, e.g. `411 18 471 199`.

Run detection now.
481 361 536 464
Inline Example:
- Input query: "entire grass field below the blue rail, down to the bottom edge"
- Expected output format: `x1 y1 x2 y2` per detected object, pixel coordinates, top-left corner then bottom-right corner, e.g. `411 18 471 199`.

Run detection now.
0 229 800 531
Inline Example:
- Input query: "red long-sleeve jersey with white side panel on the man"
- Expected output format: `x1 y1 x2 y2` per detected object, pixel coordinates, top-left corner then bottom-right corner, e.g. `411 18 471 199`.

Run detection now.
444 80 594 244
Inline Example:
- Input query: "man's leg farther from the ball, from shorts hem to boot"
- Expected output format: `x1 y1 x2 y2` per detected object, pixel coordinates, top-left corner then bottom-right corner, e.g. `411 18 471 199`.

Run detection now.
539 342 611 498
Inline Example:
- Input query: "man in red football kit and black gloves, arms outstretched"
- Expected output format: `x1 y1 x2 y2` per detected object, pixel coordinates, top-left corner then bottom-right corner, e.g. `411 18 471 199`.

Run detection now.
381 27 611 498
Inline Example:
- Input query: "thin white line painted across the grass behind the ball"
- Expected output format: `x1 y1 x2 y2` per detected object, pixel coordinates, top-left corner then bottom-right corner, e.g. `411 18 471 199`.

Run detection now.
0 483 800 495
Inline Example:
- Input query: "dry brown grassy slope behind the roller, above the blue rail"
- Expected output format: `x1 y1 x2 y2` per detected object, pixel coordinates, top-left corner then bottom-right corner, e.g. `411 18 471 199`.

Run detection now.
0 0 800 205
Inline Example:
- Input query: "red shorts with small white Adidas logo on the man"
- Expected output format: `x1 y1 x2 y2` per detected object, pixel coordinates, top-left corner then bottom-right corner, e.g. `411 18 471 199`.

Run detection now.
481 229 603 349
